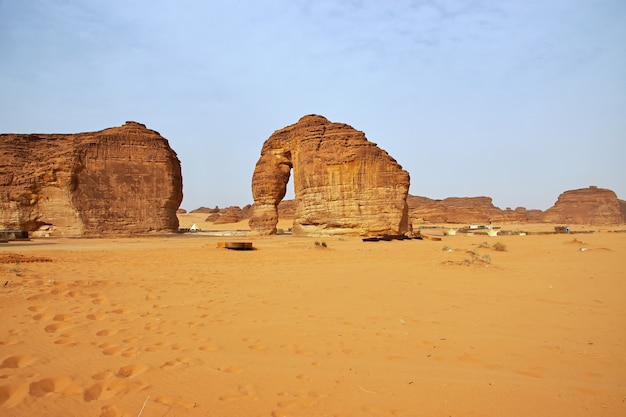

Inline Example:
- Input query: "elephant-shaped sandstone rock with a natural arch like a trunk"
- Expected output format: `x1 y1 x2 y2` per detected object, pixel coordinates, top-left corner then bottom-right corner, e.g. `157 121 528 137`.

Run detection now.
249 115 410 236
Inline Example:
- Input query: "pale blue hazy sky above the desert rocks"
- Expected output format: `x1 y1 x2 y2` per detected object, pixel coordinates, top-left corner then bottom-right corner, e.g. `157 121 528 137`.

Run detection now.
0 0 626 210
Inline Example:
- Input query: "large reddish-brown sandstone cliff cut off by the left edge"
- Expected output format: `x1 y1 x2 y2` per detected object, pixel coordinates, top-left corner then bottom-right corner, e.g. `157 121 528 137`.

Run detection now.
0 122 182 236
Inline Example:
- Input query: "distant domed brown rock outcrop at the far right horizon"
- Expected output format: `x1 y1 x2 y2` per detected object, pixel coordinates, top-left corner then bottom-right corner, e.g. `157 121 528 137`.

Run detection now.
543 186 625 224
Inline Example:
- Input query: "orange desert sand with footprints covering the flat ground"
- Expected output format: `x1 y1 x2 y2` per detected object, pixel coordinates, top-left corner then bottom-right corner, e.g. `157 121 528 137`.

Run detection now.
0 215 626 417
